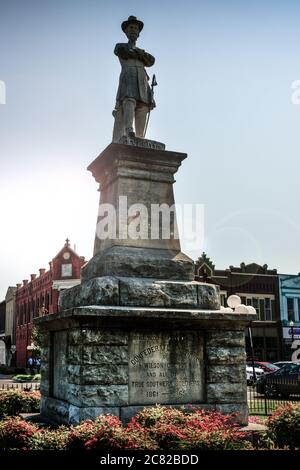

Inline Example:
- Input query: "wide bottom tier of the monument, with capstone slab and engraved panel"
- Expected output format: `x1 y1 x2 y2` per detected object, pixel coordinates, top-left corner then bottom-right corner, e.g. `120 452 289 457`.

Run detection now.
35 304 253 424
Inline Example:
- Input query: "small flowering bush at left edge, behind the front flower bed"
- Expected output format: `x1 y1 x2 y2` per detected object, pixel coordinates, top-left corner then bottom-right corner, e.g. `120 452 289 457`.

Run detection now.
0 390 40 419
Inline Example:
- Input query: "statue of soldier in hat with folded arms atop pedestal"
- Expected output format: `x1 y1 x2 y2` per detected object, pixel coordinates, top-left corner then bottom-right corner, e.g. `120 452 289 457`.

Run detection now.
113 16 155 142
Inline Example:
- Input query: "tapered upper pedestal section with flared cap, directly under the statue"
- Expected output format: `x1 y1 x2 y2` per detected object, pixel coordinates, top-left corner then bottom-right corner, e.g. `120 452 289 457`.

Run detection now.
82 144 194 281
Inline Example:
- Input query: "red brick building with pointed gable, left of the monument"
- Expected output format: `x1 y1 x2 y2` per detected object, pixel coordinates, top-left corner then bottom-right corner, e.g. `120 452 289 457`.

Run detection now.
16 239 85 367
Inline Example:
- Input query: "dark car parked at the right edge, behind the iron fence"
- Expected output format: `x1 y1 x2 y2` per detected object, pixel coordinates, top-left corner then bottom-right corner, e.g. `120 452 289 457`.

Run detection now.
256 362 300 398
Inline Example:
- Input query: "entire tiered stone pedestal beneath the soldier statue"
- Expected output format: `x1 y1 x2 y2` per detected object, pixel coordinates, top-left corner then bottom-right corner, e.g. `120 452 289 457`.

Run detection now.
35 140 252 424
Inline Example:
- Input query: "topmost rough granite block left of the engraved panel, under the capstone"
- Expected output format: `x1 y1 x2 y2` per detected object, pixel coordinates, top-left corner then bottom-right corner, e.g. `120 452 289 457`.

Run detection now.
69 328 128 346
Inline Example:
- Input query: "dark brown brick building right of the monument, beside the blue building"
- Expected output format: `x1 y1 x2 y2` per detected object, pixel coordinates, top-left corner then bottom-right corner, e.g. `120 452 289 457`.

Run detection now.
195 253 282 362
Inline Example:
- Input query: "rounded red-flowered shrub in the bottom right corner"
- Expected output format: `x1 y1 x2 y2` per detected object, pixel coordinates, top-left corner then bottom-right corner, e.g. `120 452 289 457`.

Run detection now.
266 403 300 450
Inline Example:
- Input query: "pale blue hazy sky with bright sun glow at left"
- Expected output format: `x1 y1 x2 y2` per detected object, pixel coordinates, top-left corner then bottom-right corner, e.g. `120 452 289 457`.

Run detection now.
0 0 300 300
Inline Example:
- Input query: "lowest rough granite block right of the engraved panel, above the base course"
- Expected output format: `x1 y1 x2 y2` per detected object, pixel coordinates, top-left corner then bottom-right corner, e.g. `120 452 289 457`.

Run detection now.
207 383 247 403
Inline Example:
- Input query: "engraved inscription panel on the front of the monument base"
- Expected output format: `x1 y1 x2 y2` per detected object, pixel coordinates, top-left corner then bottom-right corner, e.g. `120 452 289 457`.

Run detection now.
129 331 204 405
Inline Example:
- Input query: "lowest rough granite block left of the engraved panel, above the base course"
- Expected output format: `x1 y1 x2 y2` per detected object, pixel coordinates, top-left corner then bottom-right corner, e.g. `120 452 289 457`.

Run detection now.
67 384 128 407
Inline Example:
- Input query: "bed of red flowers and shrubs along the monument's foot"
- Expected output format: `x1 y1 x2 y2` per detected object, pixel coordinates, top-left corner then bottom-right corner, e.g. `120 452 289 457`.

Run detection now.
0 402 300 451
